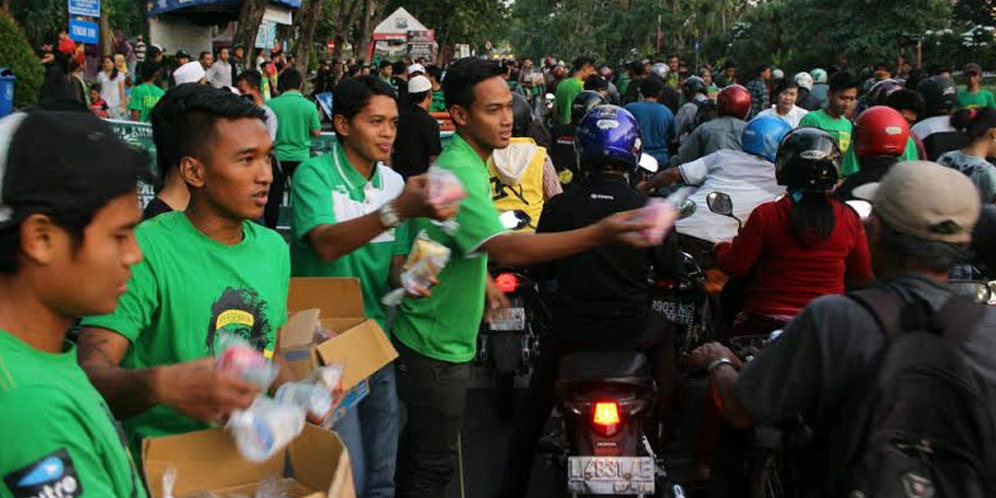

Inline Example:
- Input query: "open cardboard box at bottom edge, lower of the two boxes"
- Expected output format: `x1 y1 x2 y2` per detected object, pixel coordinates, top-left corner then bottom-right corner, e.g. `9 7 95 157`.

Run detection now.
142 424 356 498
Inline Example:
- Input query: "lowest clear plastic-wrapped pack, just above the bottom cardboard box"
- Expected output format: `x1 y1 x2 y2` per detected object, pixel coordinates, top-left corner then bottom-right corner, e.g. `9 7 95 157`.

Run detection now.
225 396 305 462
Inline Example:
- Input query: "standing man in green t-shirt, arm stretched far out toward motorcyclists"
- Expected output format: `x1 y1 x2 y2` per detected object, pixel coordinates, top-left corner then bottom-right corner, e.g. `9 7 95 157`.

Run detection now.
392 58 660 498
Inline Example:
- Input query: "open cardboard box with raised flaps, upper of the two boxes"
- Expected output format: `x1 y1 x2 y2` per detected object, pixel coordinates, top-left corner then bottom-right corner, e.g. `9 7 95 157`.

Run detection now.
277 277 398 421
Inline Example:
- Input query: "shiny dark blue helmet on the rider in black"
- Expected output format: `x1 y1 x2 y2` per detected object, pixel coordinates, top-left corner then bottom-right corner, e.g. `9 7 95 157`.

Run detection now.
574 105 643 171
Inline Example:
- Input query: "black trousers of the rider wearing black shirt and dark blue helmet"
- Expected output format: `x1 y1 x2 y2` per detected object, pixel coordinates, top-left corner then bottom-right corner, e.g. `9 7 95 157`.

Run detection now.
498 313 675 498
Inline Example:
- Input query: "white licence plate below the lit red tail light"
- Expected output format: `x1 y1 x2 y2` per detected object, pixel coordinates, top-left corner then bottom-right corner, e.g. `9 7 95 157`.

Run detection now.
567 456 654 495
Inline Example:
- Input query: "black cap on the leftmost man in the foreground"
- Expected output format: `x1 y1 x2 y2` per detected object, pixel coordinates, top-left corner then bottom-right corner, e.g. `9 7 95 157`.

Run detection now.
0 111 149 229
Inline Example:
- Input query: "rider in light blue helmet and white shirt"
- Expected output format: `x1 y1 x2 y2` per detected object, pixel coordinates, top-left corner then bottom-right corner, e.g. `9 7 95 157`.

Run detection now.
639 116 792 247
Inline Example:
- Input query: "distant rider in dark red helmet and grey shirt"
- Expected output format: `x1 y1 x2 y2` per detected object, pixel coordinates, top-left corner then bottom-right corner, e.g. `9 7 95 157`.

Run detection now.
672 85 751 165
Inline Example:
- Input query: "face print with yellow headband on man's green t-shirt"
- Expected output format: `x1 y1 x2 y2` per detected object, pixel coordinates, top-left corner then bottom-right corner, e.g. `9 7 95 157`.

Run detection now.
204 287 273 355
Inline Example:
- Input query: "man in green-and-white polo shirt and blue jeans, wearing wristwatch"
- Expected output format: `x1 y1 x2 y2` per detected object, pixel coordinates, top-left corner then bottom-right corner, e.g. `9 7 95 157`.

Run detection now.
291 75 456 496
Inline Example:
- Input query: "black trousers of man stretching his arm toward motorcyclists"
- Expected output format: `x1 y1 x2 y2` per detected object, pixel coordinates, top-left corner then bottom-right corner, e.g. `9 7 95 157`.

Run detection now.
394 341 471 498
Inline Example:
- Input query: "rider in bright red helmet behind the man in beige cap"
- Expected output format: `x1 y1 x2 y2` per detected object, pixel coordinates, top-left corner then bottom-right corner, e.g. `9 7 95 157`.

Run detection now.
836 105 910 200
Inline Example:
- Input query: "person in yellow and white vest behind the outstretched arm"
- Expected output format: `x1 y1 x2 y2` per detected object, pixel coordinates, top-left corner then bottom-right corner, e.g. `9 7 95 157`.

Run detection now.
487 94 563 232
